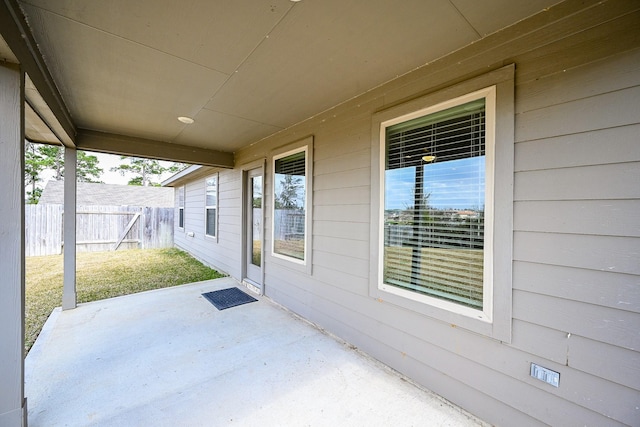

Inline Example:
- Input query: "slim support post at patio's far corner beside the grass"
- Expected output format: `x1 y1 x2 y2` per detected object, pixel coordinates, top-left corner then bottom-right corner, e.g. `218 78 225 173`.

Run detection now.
62 147 77 310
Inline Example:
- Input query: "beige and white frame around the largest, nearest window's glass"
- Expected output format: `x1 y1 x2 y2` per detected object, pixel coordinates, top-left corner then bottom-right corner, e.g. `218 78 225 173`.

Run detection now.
369 66 514 342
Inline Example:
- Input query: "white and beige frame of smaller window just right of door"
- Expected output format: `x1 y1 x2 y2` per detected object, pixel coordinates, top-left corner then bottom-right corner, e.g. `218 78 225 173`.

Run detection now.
269 137 313 274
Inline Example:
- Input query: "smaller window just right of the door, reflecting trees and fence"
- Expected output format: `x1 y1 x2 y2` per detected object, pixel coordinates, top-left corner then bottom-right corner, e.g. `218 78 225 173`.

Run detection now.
272 146 309 263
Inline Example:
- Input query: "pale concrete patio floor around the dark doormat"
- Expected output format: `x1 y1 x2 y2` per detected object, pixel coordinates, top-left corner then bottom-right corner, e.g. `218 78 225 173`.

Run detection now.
25 278 483 427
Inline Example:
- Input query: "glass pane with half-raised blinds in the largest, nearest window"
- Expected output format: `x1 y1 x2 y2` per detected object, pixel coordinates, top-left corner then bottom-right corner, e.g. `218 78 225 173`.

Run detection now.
383 98 487 310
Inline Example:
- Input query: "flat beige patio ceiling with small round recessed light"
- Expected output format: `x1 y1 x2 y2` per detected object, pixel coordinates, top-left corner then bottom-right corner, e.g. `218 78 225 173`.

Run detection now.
0 0 557 166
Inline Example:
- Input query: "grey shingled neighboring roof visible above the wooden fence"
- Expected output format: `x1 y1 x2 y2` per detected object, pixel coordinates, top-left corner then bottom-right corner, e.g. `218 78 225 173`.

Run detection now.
39 181 174 208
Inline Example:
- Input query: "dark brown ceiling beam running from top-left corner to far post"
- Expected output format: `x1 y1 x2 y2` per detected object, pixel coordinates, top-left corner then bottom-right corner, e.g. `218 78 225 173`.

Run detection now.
0 0 76 147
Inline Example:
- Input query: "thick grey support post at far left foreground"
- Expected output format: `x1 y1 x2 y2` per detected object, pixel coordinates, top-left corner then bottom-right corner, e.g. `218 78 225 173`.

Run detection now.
0 62 27 427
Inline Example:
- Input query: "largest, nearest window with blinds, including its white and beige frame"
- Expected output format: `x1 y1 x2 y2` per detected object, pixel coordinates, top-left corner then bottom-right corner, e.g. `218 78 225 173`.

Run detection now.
370 66 514 341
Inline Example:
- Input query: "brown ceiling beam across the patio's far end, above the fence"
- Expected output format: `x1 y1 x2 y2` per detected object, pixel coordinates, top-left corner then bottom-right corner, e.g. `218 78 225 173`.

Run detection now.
76 129 234 169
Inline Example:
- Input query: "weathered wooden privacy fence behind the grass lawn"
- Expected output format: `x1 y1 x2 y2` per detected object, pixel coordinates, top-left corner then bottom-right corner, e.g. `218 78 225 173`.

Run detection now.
25 204 174 256
